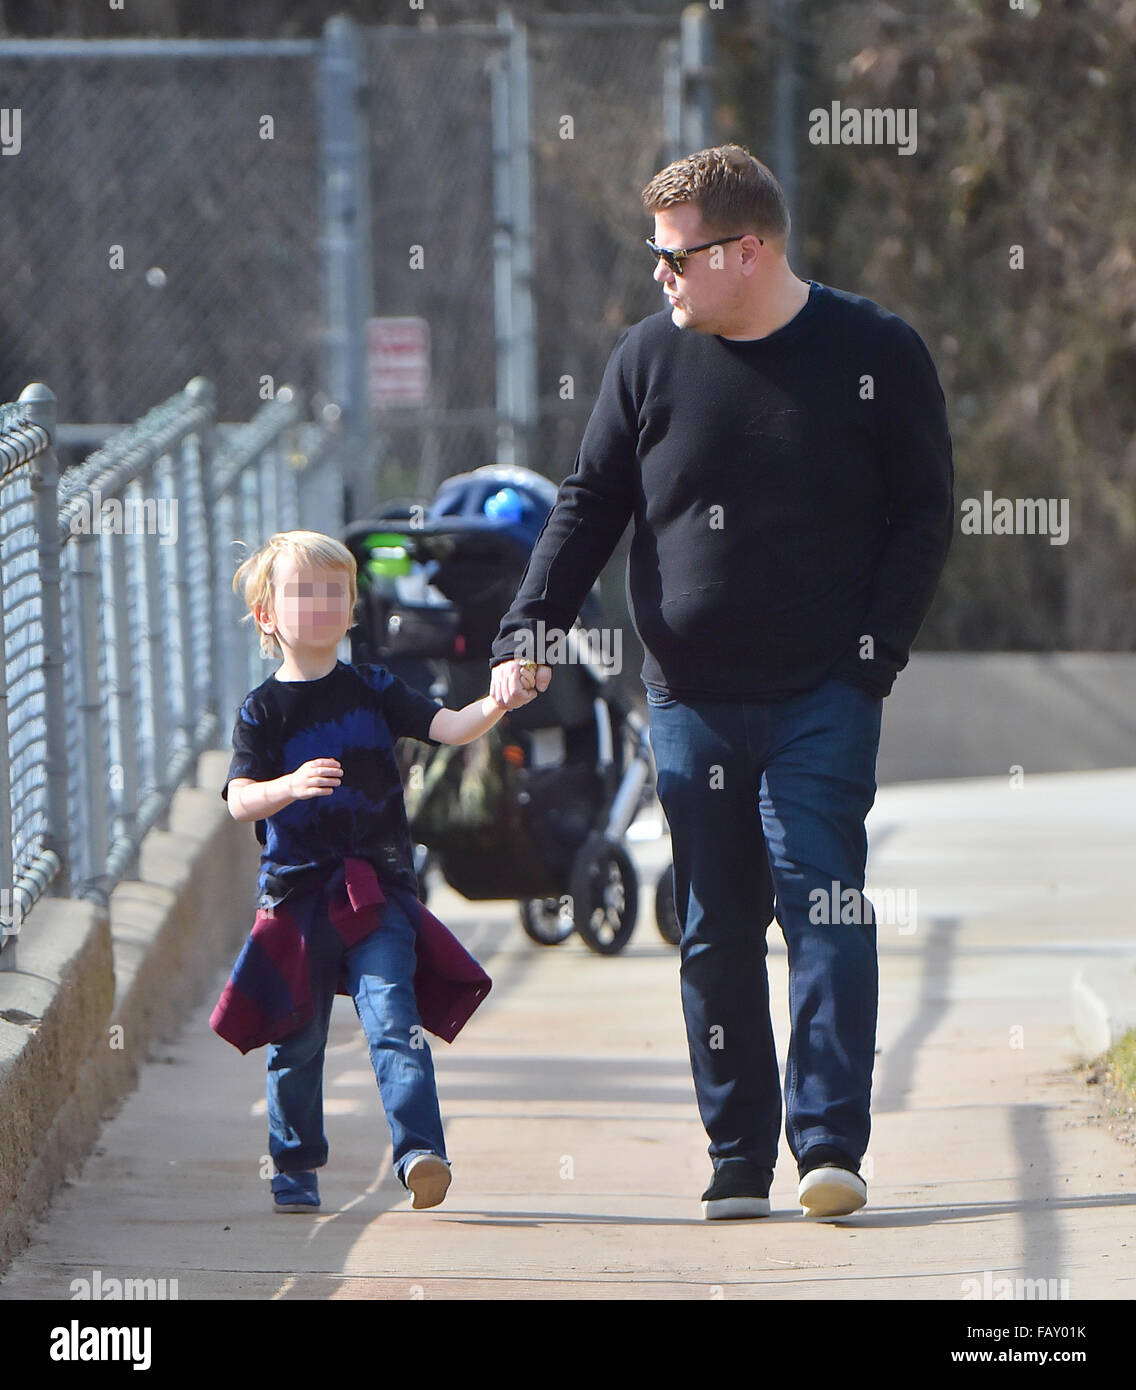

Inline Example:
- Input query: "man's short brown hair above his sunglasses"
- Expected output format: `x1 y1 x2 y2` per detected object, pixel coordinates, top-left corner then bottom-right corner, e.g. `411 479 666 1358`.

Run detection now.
640 145 791 242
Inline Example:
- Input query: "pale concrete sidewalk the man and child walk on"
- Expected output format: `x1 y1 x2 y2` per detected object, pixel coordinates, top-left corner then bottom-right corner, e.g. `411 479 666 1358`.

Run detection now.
0 771 1136 1301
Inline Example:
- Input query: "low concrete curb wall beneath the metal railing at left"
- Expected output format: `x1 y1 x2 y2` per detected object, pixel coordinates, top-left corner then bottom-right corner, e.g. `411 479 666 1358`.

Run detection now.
0 751 260 1272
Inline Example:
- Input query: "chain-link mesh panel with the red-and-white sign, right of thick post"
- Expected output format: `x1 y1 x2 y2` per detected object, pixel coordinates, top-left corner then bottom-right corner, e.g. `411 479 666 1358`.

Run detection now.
364 26 505 496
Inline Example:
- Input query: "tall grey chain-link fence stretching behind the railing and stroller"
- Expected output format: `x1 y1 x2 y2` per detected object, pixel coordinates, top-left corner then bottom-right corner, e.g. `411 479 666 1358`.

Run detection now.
0 14 679 496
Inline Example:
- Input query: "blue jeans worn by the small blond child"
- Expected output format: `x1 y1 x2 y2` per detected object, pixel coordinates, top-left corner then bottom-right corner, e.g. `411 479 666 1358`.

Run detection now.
267 899 449 1186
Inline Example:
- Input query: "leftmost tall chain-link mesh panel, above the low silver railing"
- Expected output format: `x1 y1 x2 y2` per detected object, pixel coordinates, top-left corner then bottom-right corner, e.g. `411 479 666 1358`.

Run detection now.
0 43 321 444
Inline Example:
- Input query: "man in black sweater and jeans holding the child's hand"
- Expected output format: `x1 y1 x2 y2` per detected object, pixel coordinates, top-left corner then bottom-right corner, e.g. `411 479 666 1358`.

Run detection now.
492 145 954 1218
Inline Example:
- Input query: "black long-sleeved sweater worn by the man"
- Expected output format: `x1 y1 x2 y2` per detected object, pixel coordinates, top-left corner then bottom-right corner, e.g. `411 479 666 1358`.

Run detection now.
491 281 954 699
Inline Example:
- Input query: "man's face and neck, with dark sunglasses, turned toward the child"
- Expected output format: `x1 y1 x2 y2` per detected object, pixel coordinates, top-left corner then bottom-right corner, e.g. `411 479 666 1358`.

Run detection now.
652 203 762 334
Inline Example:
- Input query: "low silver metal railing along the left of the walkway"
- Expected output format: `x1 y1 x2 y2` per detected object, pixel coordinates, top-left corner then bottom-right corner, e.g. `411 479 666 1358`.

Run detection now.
0 378 343 969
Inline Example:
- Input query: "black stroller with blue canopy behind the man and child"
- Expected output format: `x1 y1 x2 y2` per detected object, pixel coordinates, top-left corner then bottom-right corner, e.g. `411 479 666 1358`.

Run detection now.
343 464 679 955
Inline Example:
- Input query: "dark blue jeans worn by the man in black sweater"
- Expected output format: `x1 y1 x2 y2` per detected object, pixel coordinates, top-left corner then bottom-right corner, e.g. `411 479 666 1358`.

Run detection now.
647 678 883 1169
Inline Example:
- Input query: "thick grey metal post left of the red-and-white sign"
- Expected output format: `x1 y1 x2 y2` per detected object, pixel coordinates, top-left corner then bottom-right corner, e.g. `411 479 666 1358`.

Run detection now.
320 15 375 516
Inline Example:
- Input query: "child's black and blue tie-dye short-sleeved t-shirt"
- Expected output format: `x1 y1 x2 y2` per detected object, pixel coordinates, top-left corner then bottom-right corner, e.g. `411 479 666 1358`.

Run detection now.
221 660 441 908
